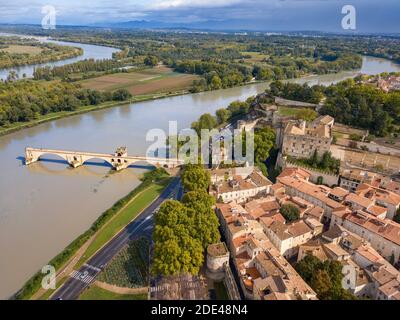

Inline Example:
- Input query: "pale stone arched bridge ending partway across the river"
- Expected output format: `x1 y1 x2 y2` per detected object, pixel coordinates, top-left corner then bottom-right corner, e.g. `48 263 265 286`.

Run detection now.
25 147 184 171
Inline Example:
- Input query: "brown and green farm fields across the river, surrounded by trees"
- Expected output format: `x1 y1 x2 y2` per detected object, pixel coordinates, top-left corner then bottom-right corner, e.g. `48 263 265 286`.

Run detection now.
80 66 198 95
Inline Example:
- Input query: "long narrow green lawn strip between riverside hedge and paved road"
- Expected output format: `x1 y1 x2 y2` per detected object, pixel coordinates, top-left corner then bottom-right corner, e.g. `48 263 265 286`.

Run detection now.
76 178 171 268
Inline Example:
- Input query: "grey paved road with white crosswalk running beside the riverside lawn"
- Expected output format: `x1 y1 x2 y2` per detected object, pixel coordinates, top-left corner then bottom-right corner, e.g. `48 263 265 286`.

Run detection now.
52 178 183 300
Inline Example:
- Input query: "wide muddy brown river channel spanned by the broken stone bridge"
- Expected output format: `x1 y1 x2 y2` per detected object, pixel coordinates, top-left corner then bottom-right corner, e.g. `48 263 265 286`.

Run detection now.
0 38 400 299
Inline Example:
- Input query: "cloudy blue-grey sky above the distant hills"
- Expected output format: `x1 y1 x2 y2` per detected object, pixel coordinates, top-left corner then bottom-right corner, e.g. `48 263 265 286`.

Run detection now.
0 0 400 33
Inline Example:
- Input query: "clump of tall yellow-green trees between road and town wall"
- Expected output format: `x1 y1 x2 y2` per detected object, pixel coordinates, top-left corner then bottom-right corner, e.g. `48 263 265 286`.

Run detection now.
152 165 220 276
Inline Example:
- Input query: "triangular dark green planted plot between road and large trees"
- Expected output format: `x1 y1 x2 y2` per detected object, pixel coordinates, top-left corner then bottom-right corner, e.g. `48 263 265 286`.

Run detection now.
98 238 150 288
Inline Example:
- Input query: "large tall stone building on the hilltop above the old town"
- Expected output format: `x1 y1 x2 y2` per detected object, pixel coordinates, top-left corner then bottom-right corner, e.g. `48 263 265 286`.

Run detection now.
282 116 334 159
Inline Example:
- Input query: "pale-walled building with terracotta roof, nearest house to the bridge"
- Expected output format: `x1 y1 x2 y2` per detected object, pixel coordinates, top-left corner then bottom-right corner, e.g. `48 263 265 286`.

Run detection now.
210 169 272 203
